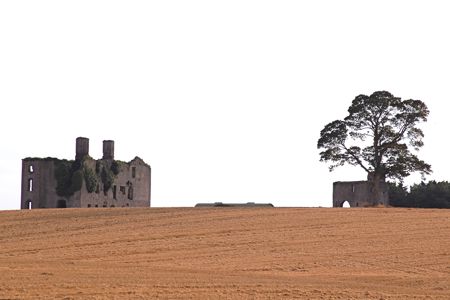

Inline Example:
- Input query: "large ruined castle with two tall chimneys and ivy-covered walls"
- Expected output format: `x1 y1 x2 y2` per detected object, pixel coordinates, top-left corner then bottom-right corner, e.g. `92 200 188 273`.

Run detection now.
21 137 151 209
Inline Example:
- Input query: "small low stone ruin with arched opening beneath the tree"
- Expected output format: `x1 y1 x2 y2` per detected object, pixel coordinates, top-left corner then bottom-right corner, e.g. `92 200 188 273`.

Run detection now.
333 180 389 207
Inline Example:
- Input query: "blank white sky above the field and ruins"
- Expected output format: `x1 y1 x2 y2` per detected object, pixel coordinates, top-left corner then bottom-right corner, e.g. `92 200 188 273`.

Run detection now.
0 0 450 209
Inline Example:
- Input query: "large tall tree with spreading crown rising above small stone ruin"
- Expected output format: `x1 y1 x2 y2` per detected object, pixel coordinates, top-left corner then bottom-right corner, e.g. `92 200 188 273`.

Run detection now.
317 91 431 202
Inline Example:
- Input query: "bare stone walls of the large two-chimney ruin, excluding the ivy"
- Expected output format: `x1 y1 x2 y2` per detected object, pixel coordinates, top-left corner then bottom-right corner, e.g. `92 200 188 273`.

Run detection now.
21 138 151 209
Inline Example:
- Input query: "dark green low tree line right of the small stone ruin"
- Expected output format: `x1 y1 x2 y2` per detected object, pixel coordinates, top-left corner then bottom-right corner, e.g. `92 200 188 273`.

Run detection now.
389 181 450 208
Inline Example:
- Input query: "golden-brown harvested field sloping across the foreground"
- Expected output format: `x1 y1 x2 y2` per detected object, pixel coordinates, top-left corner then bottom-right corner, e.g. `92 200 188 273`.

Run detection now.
0 208 450 299
